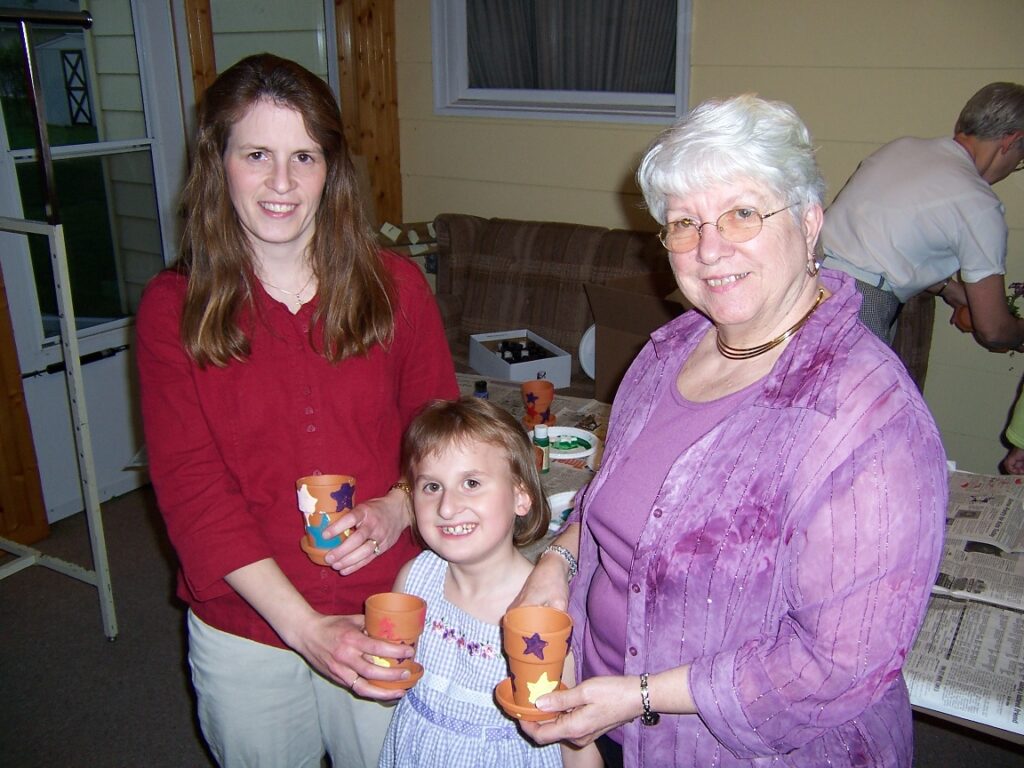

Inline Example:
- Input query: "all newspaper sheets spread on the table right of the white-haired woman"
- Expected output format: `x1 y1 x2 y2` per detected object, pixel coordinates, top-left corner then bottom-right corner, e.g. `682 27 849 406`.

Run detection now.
903 472 1024 735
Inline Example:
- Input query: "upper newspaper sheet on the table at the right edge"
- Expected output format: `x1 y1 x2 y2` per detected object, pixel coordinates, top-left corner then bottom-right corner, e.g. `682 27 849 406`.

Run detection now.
946 472 1024 552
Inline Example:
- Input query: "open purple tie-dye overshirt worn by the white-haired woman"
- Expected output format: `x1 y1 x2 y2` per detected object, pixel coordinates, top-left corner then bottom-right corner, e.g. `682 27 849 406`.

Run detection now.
569 270 947 768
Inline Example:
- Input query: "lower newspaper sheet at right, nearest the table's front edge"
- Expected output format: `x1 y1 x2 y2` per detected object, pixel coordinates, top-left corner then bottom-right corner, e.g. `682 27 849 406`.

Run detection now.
903 595 1024 735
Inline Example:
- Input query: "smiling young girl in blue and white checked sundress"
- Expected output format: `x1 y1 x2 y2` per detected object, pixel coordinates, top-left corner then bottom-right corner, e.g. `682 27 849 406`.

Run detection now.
380 397 600 768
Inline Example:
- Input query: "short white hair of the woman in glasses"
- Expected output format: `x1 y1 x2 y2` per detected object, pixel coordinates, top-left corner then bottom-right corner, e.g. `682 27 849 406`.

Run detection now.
637 93 825 224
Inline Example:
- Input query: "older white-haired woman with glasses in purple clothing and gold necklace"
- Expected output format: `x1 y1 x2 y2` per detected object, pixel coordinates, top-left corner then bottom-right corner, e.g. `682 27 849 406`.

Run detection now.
517 95 947 768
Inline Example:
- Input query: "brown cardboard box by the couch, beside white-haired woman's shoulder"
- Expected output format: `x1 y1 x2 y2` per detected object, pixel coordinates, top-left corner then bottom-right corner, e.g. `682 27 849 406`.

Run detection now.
584 271 689 402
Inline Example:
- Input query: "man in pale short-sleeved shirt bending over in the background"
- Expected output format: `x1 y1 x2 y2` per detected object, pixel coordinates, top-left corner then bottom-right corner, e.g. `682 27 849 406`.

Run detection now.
821 83 1024 350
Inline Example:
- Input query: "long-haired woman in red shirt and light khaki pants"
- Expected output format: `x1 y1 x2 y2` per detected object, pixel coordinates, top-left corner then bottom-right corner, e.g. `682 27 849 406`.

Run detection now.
137 54 458 766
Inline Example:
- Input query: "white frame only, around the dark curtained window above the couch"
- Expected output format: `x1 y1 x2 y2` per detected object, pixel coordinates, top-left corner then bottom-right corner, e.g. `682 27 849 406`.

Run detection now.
431 0 691 123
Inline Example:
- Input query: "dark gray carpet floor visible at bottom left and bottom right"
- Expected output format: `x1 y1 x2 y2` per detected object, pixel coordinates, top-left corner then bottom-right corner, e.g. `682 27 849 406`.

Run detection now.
0 486 1024 768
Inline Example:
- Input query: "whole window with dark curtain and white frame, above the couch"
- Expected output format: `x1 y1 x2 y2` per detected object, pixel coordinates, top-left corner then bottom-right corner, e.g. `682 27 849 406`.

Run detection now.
432 0 690 122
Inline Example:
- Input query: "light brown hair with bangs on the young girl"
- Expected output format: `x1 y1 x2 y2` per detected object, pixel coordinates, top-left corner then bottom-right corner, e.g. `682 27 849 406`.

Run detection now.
401 395 551 547
